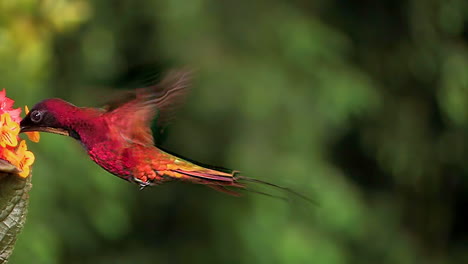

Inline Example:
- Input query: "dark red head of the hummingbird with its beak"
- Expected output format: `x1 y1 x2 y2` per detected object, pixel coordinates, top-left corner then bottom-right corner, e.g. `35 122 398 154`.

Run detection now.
20 98 78 136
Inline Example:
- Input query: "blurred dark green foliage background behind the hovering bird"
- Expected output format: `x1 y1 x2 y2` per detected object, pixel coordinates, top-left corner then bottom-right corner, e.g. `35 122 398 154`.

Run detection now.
0 0 468 264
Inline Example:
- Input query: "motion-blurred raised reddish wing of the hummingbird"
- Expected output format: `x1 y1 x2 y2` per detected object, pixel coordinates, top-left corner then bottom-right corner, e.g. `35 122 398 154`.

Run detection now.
104 71 190 146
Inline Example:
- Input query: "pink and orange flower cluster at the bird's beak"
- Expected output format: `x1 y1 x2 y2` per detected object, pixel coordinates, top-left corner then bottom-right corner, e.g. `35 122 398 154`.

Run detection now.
0 89 39 178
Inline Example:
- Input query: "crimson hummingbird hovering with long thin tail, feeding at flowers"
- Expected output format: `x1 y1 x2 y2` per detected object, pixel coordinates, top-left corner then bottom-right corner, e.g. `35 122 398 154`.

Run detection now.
20 71 308 199
